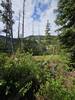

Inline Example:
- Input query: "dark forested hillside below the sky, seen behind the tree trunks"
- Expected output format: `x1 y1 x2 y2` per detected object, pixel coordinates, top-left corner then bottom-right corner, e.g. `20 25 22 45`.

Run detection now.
0 36 59 55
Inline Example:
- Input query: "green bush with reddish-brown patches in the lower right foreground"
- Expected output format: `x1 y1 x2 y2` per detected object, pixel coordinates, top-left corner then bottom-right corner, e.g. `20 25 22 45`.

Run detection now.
37 62 75 100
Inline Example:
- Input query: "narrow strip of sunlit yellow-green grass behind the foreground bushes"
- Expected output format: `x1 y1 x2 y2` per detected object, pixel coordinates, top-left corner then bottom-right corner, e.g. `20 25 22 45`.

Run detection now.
33 55 69 63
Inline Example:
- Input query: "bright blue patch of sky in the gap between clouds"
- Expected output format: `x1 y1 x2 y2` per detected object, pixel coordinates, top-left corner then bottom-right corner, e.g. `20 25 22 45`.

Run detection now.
31 0 51 21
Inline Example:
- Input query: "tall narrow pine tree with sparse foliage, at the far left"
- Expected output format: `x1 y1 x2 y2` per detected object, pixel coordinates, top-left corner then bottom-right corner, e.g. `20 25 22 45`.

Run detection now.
1 0 14 52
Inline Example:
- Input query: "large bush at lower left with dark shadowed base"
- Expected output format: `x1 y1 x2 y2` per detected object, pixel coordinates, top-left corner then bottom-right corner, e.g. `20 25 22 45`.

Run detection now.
0 53 39 100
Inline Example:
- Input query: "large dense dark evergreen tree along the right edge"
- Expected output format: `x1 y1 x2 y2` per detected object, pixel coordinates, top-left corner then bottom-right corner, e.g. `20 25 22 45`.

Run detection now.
56 0 75 66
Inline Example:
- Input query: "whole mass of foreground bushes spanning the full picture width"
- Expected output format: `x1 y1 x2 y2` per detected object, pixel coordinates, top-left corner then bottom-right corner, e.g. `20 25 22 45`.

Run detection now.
0 52 75 100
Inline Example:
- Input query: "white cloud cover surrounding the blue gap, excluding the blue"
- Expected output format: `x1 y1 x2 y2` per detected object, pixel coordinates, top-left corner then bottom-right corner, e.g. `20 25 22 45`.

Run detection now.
0 0 57 37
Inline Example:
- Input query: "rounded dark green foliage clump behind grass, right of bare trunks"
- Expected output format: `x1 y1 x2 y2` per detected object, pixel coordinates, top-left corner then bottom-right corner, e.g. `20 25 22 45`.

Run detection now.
24 38 46 55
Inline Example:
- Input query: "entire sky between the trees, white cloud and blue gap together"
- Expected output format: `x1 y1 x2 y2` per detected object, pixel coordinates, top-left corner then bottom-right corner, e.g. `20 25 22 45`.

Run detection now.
0 0 57 37
